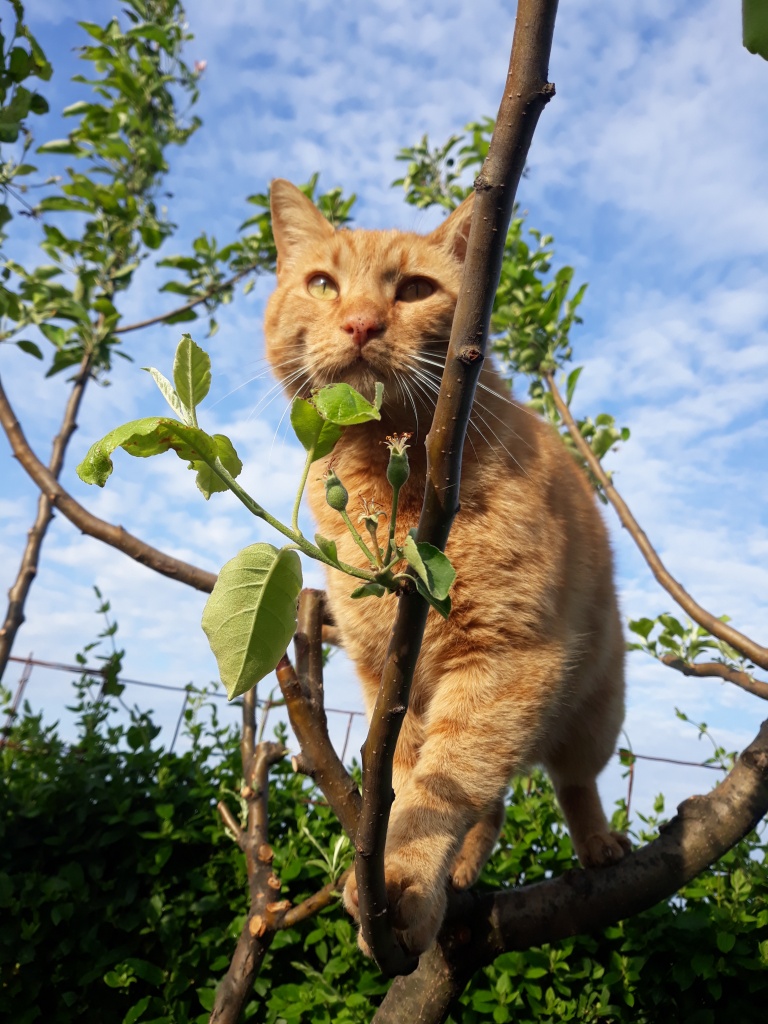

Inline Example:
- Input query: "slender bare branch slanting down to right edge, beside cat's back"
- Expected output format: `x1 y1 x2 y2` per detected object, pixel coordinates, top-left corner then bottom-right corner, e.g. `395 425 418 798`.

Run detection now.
544 372 768 681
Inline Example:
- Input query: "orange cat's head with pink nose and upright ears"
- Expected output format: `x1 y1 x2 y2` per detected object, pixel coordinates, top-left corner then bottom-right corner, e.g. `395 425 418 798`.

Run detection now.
264 178 472 417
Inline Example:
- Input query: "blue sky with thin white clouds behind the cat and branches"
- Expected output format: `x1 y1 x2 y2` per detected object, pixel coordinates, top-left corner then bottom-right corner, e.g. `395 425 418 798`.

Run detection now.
0 0 768 808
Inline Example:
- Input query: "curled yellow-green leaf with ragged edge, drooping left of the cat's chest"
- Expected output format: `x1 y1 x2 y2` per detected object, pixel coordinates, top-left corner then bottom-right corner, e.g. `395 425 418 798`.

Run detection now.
77 417 217 487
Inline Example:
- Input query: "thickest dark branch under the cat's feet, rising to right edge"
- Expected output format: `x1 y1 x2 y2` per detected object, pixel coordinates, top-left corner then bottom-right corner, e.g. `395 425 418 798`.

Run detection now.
374 721 768 1024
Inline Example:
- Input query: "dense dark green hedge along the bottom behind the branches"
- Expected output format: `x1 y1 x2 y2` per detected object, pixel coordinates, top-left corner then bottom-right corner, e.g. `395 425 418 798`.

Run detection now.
0 671 768 1024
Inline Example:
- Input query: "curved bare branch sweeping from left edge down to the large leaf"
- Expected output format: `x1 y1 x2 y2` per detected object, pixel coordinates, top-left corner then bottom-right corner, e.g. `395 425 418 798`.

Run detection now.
0 372 216 593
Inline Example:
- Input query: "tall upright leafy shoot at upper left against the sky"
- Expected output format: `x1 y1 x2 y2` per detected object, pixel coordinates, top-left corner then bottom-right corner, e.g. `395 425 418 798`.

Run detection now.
0 0 200 375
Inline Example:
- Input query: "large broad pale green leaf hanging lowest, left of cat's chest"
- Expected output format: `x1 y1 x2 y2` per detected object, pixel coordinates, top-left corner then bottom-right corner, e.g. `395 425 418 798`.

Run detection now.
203 544 301 700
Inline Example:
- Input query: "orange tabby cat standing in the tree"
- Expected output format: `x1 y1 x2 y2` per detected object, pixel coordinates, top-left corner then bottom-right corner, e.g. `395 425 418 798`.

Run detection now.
264 179 629 953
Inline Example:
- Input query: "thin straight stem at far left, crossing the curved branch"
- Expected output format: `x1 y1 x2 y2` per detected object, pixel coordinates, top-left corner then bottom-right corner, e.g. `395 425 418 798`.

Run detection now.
0 352 93 679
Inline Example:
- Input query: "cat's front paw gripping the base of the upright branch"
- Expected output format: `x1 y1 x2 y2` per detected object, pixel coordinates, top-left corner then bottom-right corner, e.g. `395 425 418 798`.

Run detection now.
344 859 446 956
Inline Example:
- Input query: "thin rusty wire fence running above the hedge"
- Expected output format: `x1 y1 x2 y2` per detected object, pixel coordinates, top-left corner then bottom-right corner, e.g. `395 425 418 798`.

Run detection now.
0 654 727 817
